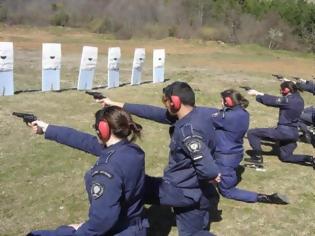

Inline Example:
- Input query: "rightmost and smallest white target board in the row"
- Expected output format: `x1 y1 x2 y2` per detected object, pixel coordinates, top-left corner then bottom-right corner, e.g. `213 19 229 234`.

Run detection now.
153 49 165 83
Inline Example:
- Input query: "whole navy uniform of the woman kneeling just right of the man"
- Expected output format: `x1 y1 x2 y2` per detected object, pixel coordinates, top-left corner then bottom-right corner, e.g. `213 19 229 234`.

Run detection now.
212 105 257 202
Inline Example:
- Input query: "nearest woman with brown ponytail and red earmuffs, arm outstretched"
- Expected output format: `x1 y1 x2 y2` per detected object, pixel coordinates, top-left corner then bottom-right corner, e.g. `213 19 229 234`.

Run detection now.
28 106 148 236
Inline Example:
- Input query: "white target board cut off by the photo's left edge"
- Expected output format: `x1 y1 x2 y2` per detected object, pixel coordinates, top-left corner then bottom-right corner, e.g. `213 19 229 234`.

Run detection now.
0 42 14 96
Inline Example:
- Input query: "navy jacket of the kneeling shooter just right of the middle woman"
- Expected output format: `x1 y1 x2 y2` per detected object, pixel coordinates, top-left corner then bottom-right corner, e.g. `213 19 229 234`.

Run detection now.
256 92 304 127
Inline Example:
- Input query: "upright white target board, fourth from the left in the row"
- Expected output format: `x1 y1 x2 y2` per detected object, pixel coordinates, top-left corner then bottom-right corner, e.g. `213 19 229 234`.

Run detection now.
107 47 121 88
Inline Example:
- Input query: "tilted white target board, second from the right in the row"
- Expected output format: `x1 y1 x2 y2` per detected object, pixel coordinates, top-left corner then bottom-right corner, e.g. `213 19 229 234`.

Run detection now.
131 48 145 85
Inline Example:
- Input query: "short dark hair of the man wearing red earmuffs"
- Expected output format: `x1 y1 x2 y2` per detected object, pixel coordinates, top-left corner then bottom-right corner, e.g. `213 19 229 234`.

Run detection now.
163 81 195 106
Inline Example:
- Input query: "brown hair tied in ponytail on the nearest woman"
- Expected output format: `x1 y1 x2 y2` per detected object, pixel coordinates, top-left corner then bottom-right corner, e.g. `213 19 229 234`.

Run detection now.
95 106 142 142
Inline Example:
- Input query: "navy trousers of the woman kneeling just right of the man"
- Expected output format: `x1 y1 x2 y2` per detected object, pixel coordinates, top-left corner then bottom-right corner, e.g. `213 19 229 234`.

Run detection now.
214 153 257 202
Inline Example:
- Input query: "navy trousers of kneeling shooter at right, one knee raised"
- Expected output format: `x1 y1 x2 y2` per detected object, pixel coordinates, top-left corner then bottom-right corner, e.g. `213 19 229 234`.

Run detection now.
247 126 307 163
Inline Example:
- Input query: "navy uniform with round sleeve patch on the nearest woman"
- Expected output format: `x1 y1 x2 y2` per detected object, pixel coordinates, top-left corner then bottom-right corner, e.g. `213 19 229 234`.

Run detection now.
30 125 148 236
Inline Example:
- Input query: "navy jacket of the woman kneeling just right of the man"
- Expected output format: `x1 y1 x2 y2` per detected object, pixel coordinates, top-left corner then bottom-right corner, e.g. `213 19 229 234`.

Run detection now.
212 105 249 154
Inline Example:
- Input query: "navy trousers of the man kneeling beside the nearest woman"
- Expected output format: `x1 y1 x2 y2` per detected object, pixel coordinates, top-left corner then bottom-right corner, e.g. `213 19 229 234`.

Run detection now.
144 176 213 236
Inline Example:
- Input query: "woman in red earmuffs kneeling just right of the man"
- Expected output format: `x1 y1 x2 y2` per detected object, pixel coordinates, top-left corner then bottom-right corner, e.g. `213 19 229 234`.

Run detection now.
212 89 287 204
